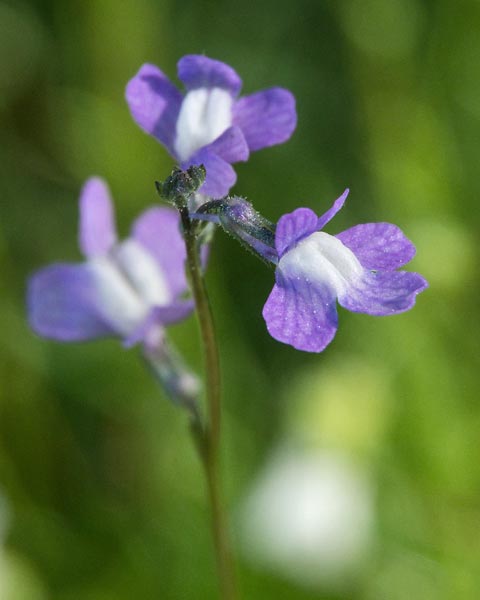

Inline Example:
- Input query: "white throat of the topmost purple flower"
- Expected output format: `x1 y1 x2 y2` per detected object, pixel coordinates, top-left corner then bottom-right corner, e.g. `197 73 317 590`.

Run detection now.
174 88 233 162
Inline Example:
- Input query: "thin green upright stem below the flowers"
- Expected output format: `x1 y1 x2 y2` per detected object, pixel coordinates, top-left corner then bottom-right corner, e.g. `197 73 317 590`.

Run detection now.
180 207 237 600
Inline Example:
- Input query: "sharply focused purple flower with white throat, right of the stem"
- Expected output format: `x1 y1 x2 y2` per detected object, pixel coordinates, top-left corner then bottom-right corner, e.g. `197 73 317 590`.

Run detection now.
263 190 428 352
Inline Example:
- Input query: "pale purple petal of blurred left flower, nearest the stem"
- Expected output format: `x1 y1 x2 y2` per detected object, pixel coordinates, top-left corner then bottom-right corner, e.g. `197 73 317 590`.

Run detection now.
132 206 187 296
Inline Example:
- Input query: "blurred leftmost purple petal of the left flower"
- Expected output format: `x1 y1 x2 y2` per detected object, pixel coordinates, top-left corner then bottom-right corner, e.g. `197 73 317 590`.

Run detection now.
27 264 114 342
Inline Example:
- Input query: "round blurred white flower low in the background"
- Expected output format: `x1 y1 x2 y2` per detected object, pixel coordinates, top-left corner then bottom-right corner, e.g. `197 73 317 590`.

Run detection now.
241 447 374 587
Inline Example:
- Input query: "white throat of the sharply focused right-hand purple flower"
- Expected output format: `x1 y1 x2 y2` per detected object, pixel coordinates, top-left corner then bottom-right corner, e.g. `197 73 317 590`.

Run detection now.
278 231 364 296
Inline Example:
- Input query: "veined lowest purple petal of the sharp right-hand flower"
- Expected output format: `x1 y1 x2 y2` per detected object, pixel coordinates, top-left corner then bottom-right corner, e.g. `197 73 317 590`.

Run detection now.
263 272 338 352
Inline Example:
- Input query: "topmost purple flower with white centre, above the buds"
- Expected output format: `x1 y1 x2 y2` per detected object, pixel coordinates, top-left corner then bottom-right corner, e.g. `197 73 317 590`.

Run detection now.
126 54 297 198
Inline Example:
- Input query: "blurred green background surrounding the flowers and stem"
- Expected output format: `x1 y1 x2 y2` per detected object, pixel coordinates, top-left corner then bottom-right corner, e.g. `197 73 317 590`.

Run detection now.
0 0 480 600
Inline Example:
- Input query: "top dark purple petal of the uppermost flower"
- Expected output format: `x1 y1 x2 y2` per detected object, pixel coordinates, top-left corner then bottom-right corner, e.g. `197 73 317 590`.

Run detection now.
177 54 242 96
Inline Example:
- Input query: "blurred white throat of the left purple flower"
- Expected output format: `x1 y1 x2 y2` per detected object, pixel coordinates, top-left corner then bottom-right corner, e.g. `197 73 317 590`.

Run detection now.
88 239 172 336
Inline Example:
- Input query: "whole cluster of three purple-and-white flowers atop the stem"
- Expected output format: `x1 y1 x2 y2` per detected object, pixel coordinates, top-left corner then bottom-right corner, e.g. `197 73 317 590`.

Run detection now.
28 55 427 394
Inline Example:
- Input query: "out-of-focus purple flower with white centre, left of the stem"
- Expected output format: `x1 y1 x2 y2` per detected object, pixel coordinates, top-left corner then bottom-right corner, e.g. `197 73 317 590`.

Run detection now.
28 177 193 351
